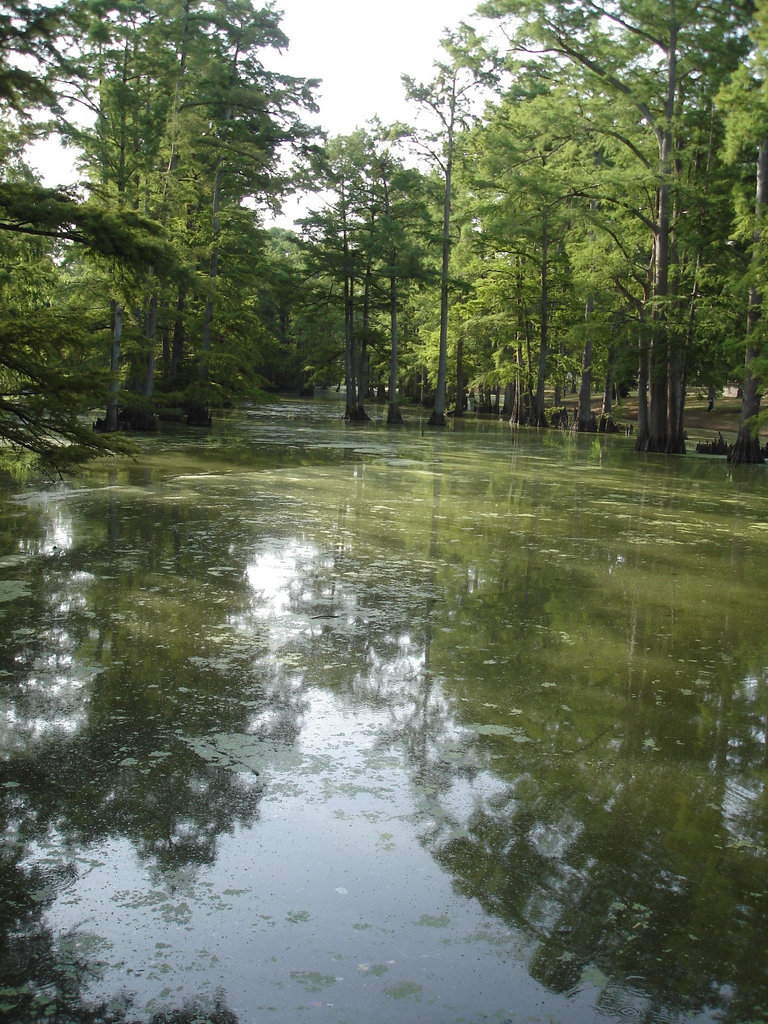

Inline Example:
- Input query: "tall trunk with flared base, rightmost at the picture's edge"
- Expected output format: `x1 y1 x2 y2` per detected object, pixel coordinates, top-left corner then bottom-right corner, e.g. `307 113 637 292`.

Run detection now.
728 138 768 464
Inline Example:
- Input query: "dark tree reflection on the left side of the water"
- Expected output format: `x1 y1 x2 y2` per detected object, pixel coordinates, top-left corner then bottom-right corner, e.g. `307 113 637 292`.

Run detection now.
0 485 280 1024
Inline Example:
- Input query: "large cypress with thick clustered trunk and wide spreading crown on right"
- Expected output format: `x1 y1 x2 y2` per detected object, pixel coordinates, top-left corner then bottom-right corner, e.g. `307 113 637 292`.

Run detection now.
481 0 748 453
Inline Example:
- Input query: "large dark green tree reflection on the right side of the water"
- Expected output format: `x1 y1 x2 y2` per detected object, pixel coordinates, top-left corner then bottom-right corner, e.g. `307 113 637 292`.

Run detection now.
339 456 768 1024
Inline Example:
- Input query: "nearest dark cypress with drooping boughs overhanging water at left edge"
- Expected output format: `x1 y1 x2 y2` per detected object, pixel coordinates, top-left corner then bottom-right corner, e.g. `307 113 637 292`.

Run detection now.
0 3 167 469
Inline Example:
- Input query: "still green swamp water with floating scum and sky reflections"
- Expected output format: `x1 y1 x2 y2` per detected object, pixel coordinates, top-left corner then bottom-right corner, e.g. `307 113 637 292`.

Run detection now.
0 402 768 1024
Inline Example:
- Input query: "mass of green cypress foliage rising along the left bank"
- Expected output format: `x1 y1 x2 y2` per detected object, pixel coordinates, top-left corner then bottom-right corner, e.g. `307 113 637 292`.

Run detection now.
0 0 314 462
